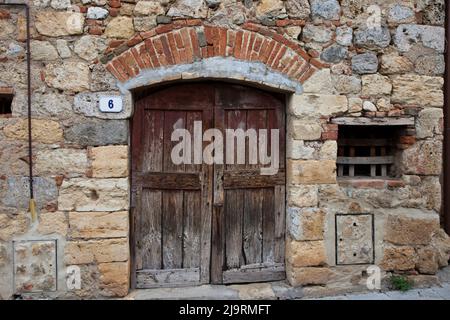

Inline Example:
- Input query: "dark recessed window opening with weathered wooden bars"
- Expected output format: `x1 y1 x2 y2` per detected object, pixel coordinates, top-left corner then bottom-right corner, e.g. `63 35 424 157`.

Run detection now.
337 125 402 178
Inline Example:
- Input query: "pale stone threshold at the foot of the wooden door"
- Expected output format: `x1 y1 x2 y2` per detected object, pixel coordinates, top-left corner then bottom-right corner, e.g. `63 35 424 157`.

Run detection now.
124 281 303 300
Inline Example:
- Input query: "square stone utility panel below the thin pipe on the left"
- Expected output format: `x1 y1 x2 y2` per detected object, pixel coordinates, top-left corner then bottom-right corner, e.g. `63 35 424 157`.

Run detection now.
14 240 57 293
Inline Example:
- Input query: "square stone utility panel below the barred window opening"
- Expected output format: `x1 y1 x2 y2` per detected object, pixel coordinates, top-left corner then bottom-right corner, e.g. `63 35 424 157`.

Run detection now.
336 214 374 265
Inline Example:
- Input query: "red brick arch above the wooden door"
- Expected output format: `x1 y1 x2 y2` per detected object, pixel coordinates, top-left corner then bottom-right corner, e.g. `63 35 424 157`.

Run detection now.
101 20 323 84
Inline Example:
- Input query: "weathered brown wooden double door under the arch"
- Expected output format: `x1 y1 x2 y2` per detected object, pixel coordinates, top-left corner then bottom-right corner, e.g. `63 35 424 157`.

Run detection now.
131 82 285 288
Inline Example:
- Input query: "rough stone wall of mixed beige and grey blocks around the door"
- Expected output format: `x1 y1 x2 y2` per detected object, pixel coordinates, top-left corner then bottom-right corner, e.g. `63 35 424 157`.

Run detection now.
0 0 450 298
